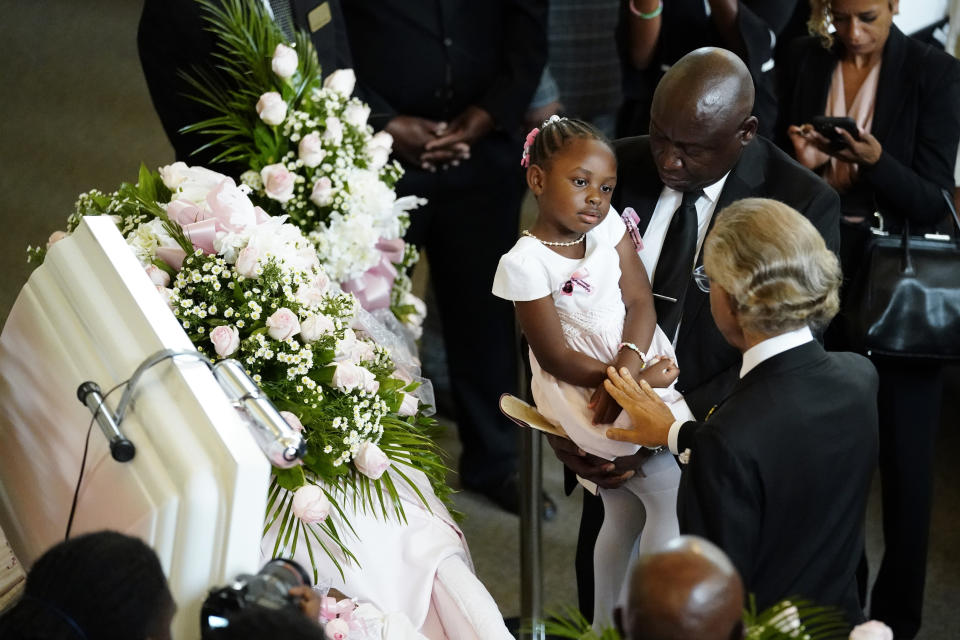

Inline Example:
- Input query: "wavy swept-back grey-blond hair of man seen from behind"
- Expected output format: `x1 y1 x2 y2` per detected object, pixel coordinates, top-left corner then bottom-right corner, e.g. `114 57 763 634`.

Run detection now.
703 198 842 335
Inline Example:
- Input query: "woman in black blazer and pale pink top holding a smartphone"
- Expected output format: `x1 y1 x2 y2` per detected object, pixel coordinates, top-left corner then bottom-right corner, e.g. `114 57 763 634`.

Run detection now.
777 0 960 640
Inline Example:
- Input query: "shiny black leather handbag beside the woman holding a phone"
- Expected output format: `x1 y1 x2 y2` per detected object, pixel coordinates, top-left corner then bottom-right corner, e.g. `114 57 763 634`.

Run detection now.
844 191 960 361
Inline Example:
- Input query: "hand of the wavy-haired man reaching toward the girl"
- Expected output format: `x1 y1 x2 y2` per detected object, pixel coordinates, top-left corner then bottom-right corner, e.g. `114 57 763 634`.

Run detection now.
603 367 674 447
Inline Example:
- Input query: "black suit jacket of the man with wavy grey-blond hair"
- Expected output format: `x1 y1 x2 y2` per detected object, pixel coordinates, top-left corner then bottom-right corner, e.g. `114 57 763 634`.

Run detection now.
677 342 878 623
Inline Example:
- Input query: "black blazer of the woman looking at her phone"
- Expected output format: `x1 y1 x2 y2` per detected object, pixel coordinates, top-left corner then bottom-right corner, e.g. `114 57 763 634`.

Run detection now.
776 25 960 230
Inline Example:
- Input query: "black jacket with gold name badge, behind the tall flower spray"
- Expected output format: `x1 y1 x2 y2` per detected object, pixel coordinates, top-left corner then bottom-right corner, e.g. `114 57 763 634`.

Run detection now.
137 0 353 172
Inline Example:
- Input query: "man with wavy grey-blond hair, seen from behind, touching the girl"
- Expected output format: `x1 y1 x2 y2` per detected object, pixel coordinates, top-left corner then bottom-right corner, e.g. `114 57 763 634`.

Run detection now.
604 198 878 624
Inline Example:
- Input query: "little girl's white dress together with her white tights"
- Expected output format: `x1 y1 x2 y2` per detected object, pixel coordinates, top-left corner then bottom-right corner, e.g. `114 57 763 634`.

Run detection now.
493 208 693 624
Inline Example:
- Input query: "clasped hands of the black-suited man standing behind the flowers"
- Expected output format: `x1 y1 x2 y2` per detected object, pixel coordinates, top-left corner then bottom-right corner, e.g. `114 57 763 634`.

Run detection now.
385 106 493 172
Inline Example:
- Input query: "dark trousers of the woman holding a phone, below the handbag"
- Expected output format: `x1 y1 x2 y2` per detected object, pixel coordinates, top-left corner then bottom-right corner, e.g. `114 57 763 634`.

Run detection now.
870 359 943 640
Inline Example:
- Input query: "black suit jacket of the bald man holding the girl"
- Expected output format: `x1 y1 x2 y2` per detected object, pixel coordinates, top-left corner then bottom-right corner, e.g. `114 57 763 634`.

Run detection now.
613 136 840 417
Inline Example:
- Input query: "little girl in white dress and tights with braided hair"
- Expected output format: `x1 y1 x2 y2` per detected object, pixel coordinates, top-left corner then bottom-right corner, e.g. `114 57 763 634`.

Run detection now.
493 116 693 626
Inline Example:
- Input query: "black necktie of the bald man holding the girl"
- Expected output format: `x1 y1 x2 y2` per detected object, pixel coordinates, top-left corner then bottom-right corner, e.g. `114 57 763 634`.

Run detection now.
653 190 703 340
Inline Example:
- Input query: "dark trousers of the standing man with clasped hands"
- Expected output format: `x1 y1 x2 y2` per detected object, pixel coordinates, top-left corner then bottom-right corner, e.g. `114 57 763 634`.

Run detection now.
397 134 523 488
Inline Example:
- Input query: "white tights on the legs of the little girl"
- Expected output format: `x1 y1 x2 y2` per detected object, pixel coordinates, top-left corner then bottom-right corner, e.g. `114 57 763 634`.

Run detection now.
593 450 680 630
